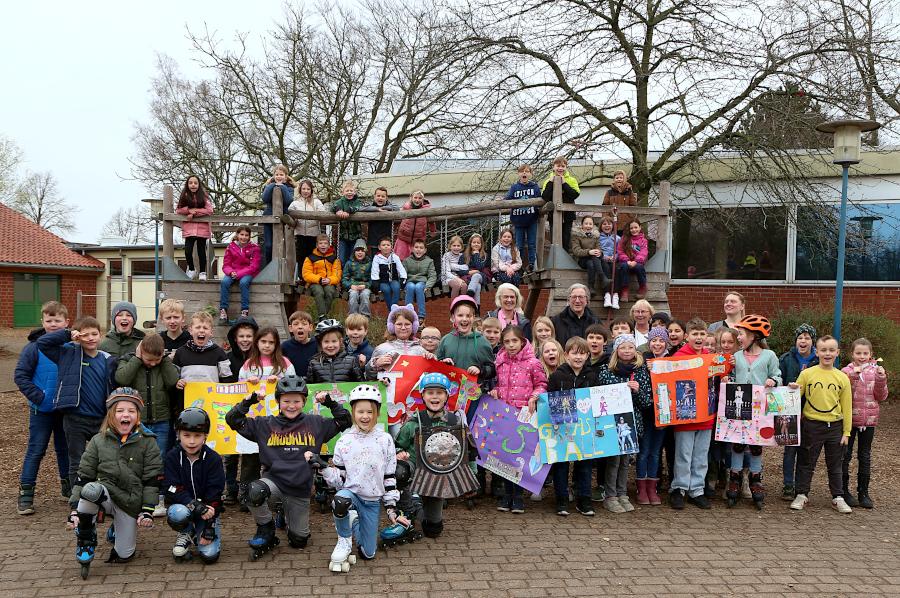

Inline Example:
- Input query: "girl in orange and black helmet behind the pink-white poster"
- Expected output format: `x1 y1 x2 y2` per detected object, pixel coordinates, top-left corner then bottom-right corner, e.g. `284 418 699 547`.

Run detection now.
726 315 781 509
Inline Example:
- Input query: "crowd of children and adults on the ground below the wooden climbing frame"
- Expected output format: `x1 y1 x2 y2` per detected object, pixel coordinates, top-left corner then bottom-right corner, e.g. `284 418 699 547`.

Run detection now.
15 283 887 570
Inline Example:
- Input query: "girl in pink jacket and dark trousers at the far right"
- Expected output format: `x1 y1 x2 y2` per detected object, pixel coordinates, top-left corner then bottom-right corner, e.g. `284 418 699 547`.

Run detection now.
841 338 887 509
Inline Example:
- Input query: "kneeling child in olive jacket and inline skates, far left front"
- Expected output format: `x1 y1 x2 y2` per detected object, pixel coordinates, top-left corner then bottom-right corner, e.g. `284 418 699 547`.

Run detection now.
67 387 162 579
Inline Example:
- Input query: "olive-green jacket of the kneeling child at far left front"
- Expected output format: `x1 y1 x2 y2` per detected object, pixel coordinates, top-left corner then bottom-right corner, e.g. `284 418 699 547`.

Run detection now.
70 426 162 517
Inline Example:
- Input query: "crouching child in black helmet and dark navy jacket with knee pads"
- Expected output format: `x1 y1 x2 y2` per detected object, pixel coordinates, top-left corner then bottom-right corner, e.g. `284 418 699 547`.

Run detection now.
163 407 225 564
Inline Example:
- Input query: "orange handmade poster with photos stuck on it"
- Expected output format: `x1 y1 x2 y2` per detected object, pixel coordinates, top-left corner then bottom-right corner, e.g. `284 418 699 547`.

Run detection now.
647 353 731 426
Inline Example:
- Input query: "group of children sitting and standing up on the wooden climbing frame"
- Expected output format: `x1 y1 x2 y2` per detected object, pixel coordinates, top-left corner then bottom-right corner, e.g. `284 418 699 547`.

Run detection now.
183 157 648 323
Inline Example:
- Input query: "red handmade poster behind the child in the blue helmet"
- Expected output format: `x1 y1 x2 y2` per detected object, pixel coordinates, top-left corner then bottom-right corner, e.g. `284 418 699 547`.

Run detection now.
379 355 481 424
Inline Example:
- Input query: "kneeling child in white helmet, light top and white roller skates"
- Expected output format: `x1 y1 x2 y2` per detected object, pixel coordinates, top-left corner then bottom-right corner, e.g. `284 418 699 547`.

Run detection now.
306 384 401 573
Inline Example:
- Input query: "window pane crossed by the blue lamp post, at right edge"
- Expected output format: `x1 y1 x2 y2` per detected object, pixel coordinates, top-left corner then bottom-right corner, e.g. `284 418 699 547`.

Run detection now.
797 203 900 282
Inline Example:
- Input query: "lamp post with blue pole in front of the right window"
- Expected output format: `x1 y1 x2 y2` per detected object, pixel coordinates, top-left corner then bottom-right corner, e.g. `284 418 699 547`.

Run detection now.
816 119 881 342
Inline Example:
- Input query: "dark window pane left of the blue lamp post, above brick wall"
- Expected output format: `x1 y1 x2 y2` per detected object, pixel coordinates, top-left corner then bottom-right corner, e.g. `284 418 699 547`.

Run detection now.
672 208 787 280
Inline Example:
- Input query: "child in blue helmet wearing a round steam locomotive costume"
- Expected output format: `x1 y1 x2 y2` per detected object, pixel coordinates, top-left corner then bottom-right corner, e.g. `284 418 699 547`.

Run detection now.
396 372 478 538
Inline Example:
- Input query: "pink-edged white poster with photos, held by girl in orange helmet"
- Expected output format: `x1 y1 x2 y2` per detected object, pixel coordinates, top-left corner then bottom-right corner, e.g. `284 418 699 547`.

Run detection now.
716 383 800 446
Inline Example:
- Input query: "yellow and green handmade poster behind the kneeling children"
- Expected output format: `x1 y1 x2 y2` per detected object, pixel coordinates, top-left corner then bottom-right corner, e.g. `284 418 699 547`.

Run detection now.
184 381 387 455
